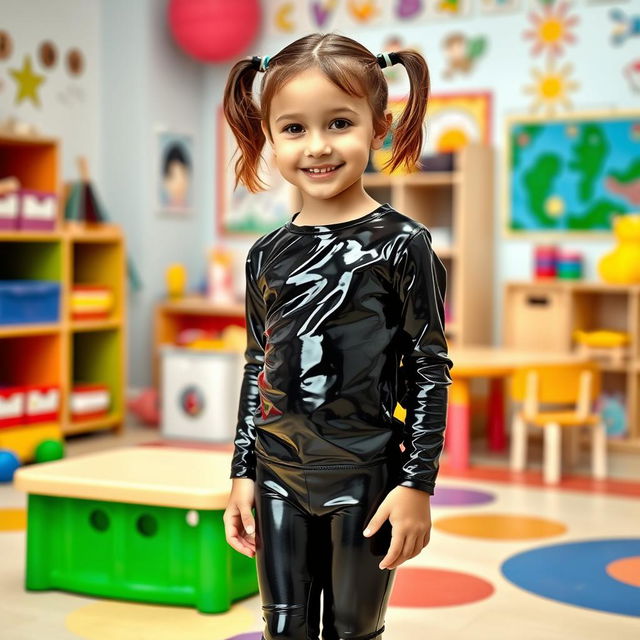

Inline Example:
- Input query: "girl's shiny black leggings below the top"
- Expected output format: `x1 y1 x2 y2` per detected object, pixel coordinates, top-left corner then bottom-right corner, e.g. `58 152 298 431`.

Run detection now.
256 459 395 640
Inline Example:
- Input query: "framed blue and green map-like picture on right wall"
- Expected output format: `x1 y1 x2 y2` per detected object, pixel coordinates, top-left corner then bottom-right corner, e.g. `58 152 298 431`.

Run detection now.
502 110 640 239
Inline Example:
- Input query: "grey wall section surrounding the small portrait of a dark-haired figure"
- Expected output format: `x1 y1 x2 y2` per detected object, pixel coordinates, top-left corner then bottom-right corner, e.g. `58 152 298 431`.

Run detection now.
100 0 205 388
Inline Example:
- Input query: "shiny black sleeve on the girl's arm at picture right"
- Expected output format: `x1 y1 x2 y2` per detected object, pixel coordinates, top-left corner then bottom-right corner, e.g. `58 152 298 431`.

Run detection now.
395 227 453 495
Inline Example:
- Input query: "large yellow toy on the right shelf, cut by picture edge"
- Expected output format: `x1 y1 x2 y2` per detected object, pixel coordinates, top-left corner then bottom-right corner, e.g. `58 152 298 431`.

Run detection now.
598 213 640 284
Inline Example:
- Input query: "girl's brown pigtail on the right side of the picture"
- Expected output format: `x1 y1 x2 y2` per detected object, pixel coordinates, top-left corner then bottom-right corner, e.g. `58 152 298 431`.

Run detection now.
382 50 431 172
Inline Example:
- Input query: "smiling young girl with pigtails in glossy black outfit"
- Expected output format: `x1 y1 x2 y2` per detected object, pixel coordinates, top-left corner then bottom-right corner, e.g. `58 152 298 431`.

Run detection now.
224 33 453 640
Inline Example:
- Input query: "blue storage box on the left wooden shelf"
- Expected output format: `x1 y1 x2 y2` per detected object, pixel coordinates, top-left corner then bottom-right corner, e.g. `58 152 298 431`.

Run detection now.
0 280 61 324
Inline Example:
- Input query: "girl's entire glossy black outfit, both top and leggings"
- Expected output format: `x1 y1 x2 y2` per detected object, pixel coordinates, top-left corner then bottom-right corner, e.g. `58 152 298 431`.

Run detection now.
231 203 452 640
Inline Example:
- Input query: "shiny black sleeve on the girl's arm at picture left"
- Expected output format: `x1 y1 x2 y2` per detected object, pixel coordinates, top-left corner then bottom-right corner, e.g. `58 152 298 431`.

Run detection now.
229 249 266 480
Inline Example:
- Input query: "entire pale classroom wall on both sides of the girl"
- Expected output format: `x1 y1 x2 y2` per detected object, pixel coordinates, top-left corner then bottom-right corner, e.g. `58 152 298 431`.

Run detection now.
0 0 640 387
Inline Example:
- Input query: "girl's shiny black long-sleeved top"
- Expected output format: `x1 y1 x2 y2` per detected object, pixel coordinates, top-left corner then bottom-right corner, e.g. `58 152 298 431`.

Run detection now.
230 203 453 494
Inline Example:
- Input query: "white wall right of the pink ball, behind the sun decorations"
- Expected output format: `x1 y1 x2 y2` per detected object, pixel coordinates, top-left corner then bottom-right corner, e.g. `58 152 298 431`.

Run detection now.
206 0 640 348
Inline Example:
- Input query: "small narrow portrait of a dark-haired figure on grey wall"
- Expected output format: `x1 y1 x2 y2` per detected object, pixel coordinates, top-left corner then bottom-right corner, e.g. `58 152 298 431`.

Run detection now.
156 129 194 214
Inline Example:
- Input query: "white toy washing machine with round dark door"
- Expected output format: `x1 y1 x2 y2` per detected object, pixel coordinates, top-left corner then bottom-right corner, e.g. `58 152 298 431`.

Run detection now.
161 345 244 442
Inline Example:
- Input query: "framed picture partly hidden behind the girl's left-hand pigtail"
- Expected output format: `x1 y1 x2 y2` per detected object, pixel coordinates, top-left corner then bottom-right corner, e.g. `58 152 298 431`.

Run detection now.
215 105 299 235
